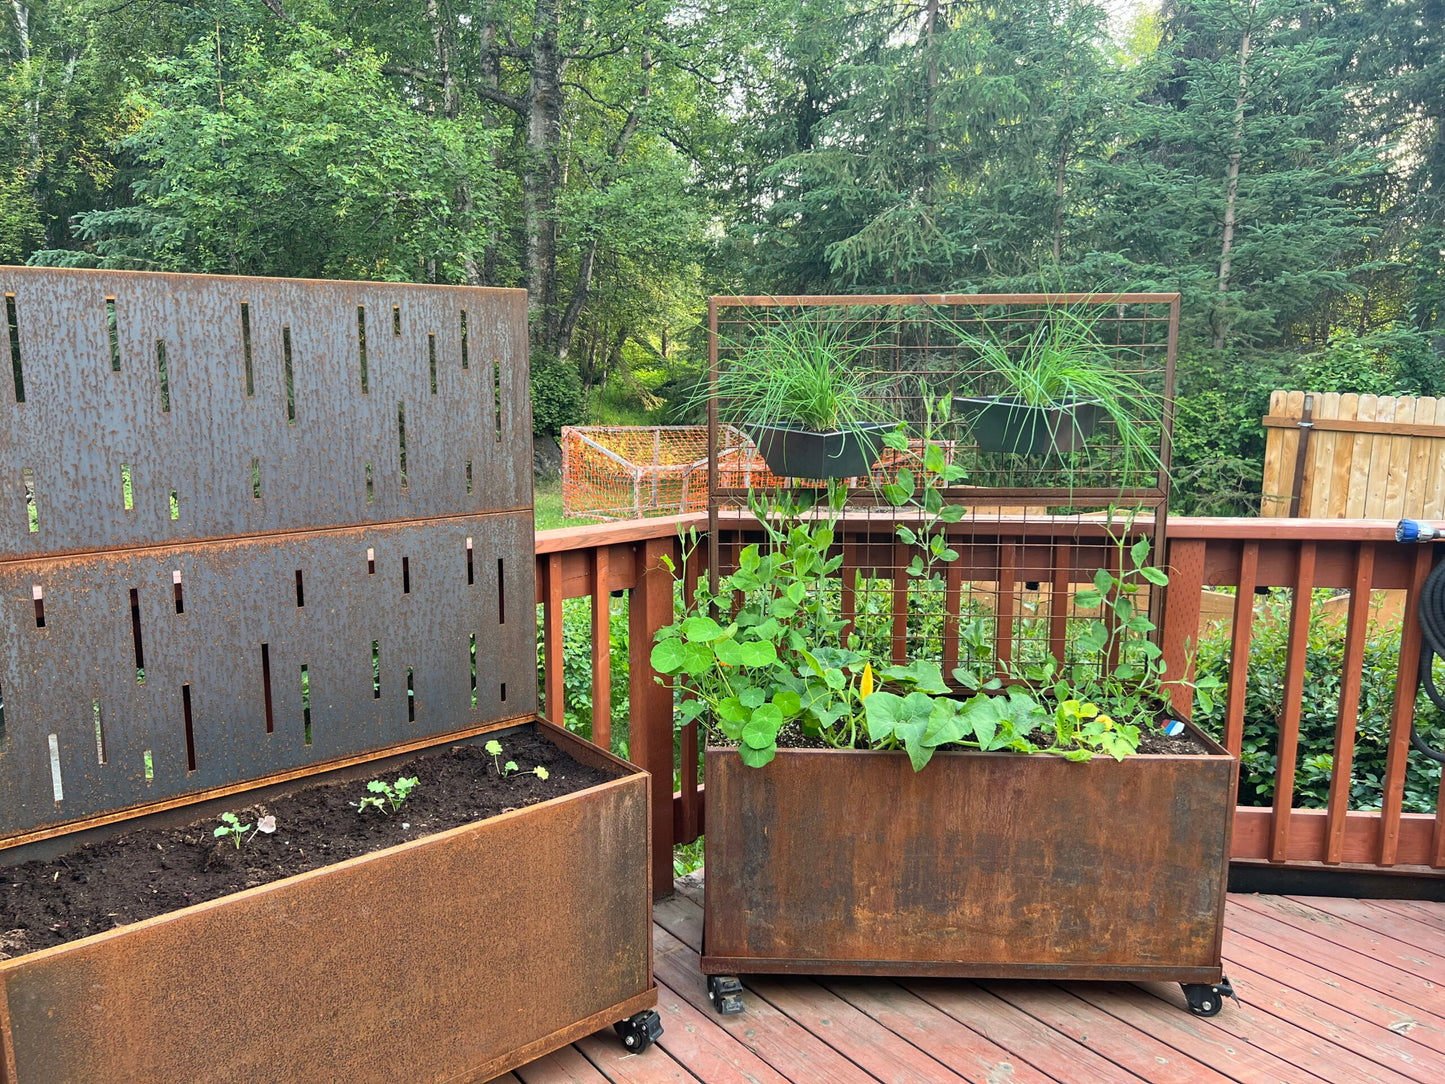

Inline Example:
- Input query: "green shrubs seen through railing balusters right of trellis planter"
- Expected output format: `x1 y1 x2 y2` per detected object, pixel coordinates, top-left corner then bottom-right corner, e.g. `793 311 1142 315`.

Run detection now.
1195 604 1445 812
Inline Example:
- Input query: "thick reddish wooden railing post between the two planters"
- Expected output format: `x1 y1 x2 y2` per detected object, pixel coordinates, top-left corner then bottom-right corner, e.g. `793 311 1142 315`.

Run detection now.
627 538 679 899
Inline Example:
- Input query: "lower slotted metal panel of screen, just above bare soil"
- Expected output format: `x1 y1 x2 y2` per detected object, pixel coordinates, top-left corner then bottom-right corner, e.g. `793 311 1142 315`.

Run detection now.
0 512 536 837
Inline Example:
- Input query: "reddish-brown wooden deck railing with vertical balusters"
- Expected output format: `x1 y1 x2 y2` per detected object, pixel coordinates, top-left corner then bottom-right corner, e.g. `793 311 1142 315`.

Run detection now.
536 515 1445 895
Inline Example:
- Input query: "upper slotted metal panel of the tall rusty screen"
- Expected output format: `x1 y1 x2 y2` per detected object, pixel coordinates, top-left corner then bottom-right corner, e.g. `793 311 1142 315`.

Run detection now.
0 267 532 555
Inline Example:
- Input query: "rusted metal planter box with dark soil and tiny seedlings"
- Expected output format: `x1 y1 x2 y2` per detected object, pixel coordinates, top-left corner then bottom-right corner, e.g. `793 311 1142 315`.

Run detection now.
0 723 657 1084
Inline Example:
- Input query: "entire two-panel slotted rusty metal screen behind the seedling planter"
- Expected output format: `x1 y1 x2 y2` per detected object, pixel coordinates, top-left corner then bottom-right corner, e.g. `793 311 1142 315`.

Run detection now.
0 267 536 843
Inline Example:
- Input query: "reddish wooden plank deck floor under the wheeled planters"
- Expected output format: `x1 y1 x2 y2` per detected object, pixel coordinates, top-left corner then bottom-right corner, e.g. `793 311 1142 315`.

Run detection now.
500 877 1445 1084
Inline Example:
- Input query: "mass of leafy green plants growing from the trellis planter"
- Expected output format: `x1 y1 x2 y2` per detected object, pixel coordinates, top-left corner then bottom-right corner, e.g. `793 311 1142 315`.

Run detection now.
652 479 1209 770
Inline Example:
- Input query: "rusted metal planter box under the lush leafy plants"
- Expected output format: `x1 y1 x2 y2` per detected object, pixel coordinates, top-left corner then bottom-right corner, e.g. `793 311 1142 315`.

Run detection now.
702 731 1237 983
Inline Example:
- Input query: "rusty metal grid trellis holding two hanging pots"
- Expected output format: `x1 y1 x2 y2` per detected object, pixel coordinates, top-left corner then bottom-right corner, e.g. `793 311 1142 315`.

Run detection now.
708 293 1179 679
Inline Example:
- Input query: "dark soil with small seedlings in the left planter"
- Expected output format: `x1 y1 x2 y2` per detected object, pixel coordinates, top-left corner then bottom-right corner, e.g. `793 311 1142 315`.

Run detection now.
0 730 613 960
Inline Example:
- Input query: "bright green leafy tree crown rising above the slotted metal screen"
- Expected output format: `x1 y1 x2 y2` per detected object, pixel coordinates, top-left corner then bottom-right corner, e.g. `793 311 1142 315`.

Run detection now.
32 23 494 280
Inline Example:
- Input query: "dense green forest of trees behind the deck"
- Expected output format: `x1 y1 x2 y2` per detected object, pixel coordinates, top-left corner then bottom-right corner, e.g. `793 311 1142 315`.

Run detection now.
0 0 1445 513
